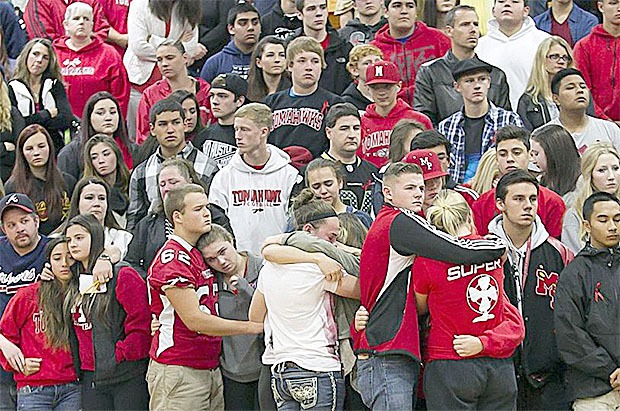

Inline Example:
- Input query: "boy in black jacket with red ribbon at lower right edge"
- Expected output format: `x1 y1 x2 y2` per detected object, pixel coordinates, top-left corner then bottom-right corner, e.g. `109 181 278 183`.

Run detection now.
555 192 620 411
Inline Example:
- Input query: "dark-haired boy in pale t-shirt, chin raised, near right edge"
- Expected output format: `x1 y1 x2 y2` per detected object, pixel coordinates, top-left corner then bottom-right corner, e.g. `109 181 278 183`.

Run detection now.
548 68 620 154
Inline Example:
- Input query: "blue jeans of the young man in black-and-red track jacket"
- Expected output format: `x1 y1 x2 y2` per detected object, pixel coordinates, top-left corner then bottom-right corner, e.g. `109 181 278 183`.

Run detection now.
357 355 420 411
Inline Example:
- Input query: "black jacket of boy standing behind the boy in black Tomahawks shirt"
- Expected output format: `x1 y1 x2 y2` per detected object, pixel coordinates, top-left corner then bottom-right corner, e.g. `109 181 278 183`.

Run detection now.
290 26 353 94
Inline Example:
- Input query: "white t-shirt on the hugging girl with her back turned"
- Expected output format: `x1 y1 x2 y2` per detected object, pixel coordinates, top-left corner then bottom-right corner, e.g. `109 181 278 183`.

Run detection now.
257 262 341 372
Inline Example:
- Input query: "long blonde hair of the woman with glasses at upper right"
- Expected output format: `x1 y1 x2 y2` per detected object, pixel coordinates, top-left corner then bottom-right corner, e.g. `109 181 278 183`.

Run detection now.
525 36 575 104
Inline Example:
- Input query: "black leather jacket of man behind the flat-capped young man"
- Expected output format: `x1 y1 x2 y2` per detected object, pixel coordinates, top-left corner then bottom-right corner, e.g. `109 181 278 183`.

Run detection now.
413 50 512 126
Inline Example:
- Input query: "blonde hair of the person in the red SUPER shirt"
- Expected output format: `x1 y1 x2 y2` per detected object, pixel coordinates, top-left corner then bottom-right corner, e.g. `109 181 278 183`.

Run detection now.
426 190 471 237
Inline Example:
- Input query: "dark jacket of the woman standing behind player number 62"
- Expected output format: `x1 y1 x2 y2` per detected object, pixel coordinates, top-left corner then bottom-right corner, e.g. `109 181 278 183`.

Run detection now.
123 204 232 278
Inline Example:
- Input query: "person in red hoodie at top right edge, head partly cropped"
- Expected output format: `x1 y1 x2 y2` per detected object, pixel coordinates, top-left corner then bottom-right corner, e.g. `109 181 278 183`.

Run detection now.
575 0 620 122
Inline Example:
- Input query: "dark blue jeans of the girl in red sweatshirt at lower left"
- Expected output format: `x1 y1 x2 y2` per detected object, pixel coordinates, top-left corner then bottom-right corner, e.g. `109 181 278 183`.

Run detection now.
17 382 82 411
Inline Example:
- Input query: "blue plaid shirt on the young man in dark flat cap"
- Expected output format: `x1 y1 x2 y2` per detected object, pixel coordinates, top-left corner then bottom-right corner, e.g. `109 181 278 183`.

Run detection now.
437 101 523 183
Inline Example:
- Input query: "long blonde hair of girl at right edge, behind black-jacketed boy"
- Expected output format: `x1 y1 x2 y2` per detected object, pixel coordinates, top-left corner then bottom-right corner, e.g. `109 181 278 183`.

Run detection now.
573 143 620 240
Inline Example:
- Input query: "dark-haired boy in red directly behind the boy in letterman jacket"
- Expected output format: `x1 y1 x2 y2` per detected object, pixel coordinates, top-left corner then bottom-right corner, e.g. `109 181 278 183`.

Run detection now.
471 126 566 238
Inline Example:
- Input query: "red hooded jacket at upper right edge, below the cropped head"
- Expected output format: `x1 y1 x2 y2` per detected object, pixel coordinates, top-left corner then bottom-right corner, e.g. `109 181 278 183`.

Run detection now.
575 24 620 121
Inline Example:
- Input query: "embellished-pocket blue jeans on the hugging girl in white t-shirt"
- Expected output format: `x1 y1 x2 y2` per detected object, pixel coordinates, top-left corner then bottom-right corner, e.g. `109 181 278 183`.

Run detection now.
271 362 345 411
